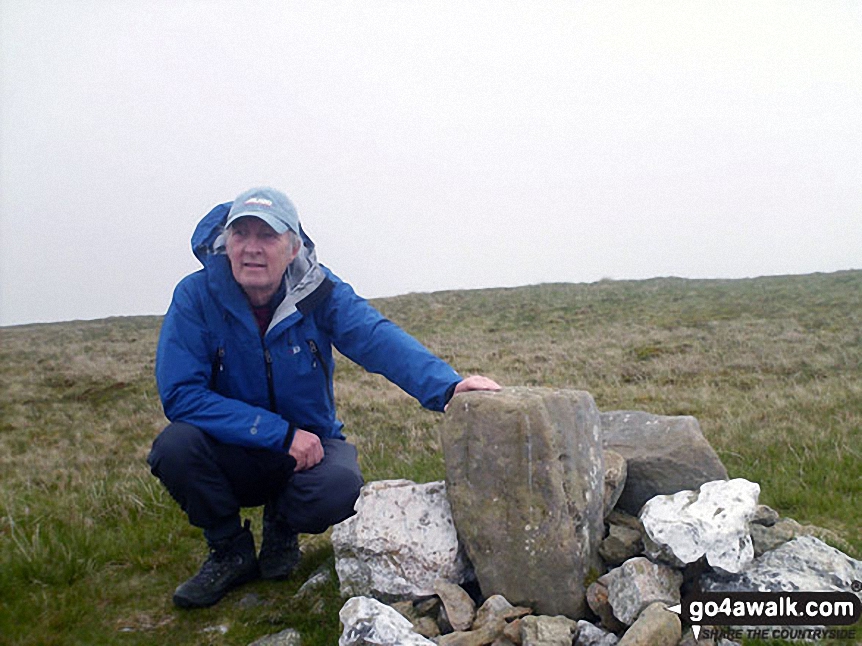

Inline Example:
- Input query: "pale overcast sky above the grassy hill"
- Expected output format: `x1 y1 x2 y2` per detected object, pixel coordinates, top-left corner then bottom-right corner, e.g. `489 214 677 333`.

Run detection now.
0 0 862 325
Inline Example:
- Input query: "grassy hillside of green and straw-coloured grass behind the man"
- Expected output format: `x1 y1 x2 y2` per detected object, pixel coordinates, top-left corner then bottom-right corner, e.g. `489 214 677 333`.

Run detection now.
0 271 862 644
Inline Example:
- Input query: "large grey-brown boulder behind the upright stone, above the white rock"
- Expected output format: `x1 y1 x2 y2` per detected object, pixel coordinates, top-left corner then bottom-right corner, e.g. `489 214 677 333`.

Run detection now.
601 411 727 515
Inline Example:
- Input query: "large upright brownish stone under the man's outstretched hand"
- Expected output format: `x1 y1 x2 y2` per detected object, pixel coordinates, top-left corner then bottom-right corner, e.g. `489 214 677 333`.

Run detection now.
442 388 604 618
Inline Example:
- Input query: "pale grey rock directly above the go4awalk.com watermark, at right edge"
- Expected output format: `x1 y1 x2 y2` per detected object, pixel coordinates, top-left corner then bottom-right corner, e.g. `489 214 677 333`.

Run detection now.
701 536 862 598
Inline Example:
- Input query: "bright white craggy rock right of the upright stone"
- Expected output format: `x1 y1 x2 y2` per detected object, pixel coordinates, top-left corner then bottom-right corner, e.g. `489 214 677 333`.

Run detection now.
640 478 760 572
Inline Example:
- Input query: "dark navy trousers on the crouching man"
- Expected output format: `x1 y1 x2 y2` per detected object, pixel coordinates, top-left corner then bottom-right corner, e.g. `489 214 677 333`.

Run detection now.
147 422 363 541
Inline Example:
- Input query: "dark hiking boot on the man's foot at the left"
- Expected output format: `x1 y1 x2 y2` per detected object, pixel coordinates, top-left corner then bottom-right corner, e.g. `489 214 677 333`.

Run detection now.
174 521 258 608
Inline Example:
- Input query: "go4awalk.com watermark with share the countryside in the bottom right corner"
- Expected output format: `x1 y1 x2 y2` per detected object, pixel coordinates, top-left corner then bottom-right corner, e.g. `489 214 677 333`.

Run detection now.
668 586 862 641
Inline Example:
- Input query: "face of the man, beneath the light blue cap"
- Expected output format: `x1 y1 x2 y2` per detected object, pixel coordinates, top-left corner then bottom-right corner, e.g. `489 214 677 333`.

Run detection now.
226 216 298 305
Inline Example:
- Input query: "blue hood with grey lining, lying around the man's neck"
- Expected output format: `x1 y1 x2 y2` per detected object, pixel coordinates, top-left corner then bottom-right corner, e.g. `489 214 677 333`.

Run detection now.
192 202 326 318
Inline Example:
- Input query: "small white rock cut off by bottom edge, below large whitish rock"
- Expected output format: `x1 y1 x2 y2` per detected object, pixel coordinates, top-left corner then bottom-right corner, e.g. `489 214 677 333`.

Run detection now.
338 597 434 646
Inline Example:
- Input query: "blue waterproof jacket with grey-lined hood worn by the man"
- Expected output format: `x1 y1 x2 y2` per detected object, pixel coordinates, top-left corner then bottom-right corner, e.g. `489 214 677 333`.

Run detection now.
156 202 461 450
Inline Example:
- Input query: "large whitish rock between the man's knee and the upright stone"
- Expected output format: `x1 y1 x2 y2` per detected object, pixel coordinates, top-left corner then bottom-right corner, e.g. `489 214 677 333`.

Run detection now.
332 480 469 601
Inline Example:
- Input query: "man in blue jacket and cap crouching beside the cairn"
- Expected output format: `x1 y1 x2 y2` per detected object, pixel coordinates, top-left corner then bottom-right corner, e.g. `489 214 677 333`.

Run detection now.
148 188 499 608
